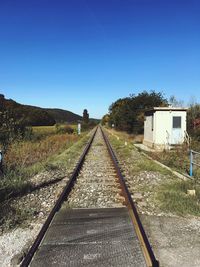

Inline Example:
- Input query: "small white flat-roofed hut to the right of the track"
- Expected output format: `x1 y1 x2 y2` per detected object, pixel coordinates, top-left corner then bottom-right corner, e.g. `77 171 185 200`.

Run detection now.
143 107 187 150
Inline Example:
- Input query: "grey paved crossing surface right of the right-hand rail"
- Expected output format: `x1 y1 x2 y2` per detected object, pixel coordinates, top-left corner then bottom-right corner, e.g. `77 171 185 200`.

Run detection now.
140 215 200 267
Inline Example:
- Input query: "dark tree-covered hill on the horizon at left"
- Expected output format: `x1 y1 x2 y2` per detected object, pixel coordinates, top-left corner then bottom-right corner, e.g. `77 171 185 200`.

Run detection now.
0 94 82 126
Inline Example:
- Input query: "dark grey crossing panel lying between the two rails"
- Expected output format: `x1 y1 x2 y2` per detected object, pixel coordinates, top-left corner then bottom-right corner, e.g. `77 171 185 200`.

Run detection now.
31 208 146 267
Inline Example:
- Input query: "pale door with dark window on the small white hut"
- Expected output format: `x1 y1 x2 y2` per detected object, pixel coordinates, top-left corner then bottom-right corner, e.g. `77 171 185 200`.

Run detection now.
171 116 182 145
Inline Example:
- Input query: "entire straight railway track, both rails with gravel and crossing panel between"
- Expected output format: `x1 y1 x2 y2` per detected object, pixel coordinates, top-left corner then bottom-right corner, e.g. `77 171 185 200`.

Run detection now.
21 127 159 267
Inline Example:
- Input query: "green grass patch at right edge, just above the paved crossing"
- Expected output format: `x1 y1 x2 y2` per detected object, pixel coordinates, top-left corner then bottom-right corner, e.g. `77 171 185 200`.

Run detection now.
156 181 200 216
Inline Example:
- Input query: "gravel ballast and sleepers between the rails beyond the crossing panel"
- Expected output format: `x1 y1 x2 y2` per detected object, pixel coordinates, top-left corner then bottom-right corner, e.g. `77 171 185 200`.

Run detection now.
67 129 124 208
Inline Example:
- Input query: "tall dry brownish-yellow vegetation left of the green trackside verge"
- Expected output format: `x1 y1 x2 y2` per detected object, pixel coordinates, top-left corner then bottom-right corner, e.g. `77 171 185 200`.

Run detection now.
0 127 90 201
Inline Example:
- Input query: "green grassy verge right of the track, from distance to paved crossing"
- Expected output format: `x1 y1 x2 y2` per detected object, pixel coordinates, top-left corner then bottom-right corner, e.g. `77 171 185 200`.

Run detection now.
105 130 200 216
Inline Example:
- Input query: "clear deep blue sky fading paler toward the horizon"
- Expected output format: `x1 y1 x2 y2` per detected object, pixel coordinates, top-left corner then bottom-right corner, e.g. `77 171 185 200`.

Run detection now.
0 0 200 118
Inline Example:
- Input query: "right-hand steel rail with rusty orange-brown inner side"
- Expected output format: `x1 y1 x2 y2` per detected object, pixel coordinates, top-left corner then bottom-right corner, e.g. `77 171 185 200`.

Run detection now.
100 127 159 267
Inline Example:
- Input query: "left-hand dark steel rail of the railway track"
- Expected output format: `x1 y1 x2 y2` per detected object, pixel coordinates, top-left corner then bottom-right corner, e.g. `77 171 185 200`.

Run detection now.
20 128 97 267
